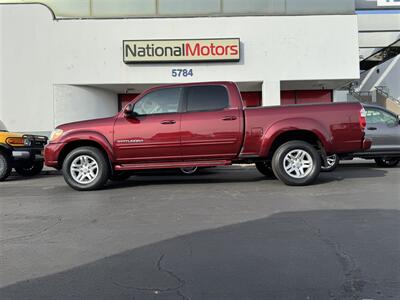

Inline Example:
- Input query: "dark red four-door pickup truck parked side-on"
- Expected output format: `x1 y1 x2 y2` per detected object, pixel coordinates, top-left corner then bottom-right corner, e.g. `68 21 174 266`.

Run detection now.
45 82 371 190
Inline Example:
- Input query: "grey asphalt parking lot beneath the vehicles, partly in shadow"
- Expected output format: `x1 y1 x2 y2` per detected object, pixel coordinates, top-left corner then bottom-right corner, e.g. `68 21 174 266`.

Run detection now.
0 162 400 300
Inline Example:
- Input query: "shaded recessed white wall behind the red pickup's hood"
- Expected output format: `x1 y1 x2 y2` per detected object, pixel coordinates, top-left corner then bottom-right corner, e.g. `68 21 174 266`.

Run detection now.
54 85 118 126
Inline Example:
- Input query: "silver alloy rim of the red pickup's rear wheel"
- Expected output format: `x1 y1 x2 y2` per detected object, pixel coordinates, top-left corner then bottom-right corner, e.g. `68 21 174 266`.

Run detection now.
283 149 314 179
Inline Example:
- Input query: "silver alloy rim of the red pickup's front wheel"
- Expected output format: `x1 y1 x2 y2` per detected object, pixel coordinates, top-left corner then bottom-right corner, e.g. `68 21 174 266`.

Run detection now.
70 155 99 184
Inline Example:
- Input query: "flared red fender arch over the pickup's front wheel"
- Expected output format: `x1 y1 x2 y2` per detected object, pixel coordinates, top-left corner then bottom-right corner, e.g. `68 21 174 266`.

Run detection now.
56 130 114 161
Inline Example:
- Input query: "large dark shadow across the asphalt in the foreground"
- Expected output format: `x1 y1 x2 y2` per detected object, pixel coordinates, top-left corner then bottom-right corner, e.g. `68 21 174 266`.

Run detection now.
0 209 400 300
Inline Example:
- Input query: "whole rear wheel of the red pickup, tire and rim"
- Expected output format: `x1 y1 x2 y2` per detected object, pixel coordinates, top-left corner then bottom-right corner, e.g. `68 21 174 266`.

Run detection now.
272 141 321 186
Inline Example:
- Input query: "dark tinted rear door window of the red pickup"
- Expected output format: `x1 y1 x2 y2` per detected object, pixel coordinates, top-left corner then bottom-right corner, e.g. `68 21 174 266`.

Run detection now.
186 85 229 112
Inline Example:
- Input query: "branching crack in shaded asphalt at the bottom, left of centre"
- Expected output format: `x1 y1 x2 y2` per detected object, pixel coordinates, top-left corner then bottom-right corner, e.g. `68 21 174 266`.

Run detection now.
113 254 189 300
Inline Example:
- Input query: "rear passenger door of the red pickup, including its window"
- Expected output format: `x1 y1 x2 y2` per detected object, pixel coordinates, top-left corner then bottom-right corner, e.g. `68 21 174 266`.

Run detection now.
181 85 242 160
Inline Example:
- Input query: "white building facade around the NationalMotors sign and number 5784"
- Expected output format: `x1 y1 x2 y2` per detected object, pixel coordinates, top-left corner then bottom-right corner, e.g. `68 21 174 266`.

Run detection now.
0 4 359 131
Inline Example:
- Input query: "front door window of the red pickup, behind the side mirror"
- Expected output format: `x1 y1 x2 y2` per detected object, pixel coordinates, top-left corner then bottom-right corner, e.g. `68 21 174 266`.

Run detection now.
133 88 182 115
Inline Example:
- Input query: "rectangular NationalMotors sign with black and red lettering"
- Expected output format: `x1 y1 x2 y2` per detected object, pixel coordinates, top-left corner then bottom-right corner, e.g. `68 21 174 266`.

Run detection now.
123 38 240 64
